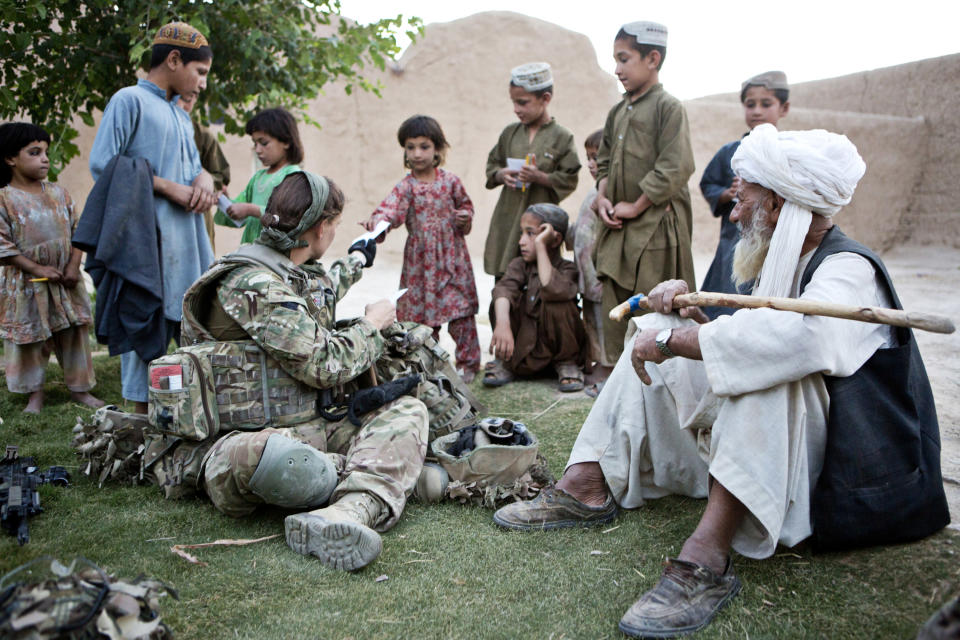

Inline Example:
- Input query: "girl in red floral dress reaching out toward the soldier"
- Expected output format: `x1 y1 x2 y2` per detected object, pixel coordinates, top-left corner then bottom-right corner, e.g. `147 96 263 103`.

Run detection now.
362 115 480 383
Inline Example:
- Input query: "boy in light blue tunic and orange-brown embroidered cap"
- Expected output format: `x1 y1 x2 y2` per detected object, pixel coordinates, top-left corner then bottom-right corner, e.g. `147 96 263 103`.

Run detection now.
90 22 216 413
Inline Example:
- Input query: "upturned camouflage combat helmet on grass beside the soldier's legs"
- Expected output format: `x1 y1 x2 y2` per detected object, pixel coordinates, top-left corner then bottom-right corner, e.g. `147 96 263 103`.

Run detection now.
430 418 553 508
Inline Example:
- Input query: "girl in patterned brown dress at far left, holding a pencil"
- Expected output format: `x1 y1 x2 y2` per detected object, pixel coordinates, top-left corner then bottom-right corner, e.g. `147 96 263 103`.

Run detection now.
0 122 103 413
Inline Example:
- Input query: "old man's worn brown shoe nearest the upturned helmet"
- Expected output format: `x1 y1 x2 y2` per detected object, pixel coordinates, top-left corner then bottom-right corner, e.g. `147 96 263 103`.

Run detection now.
493 485 617 531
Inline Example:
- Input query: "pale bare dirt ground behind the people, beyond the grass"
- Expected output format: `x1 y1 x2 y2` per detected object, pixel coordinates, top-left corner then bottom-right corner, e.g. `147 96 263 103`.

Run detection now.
338 246 960 528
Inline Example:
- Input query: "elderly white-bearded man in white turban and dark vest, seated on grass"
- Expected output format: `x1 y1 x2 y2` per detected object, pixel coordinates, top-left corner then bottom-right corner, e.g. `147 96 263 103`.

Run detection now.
494 125 949 637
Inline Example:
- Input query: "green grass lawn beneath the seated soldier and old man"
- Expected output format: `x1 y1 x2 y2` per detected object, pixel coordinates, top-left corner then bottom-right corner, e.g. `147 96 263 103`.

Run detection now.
0 357 960 639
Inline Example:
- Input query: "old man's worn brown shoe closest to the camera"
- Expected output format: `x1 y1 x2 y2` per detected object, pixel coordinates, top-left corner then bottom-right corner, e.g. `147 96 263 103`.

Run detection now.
620 558 740 638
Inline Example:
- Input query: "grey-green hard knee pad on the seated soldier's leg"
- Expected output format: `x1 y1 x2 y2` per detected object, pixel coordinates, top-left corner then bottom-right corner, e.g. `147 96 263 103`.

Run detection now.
250 433 337 509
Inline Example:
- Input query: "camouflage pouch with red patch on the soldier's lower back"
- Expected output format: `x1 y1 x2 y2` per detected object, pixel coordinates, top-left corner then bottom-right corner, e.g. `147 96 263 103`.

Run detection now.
147 344 220 440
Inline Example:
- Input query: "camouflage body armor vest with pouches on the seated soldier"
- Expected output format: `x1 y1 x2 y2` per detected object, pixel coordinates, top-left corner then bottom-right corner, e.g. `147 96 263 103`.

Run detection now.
143 244 485 498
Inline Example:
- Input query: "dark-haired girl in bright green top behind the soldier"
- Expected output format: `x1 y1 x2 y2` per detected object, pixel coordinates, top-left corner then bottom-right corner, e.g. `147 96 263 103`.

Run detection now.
214 107 303 244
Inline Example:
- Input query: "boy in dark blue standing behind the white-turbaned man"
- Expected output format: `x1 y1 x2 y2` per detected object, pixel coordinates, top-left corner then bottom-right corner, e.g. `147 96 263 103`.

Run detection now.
700 71 790 320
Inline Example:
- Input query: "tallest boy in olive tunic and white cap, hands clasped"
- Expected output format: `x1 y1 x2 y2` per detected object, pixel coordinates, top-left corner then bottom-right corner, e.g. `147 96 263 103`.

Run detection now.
595 22 696 362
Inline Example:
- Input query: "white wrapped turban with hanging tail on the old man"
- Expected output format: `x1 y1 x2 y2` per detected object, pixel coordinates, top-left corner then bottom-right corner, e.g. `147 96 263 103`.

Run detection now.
730 124 867 297
